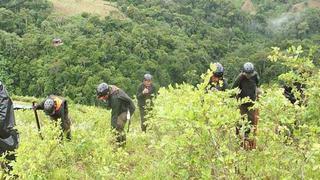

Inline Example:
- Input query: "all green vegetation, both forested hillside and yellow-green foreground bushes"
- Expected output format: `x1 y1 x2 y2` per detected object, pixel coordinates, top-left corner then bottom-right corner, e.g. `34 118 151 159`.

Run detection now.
0 0 320 179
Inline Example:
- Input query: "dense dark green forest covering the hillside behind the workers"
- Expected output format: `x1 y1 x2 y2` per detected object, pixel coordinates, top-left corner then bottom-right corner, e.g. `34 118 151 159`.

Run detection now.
0 0 320 104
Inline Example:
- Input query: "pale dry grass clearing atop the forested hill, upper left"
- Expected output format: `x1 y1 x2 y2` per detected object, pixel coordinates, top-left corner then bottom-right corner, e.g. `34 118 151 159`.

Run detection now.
50 0 125 19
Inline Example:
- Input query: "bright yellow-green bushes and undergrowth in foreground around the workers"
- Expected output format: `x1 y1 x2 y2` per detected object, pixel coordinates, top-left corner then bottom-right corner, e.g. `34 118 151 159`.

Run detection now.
0 47 320 179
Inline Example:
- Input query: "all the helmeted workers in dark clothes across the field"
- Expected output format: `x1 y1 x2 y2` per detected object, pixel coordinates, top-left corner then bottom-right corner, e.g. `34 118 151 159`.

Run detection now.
0 62 300 172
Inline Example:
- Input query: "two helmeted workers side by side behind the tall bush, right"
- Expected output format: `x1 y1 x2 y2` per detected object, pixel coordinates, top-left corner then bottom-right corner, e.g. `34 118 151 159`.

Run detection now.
207 62 260 150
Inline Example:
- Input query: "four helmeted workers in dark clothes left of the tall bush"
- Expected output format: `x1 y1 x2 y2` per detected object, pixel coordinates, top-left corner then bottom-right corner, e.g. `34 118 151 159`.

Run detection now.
0 69 156 170
